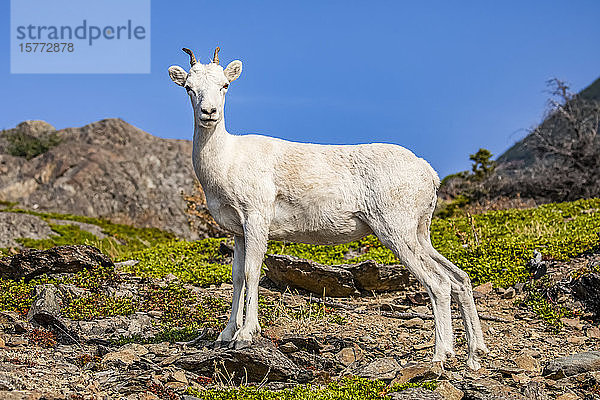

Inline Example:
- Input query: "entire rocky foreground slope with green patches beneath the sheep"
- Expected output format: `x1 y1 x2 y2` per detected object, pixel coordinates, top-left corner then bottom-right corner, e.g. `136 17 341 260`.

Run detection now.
0 200 600 400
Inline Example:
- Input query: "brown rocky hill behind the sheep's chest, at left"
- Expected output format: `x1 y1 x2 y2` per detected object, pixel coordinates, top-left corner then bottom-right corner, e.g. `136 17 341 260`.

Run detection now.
0 119 216 239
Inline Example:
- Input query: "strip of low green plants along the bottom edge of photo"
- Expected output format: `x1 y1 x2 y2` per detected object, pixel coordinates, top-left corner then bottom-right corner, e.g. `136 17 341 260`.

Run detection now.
186 377 436 400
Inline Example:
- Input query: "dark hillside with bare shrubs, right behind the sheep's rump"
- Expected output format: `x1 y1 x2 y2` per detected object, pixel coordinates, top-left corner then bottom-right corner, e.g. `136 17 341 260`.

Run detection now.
440 79 600 204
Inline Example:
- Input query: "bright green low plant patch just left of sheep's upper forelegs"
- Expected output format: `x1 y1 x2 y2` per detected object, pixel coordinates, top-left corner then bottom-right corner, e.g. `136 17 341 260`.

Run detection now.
120 239 231 286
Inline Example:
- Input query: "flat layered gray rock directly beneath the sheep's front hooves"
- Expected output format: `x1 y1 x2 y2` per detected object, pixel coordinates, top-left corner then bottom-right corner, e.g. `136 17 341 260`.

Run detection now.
175 338 311 382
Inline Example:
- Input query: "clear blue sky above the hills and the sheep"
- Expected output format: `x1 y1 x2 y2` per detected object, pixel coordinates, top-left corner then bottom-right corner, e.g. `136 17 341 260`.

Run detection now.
0 0 600 176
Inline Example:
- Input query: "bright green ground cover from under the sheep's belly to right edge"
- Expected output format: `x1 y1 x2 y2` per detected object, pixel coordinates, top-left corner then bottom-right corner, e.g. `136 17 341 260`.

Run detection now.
269 199 600 286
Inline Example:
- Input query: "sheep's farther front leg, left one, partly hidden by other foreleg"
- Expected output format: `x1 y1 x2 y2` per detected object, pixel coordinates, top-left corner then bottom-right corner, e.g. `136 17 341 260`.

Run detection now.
215 236 246 347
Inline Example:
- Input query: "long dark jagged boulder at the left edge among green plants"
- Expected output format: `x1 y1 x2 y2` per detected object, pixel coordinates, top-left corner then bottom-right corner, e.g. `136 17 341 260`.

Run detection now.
0 245 114 281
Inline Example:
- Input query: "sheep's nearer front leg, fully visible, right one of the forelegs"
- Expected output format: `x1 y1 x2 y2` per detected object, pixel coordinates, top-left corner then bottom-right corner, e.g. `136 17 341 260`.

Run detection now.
230 214 269 349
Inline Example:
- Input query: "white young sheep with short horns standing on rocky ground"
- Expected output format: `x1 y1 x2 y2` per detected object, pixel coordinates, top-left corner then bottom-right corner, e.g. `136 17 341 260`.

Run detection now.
169 48 488 369
